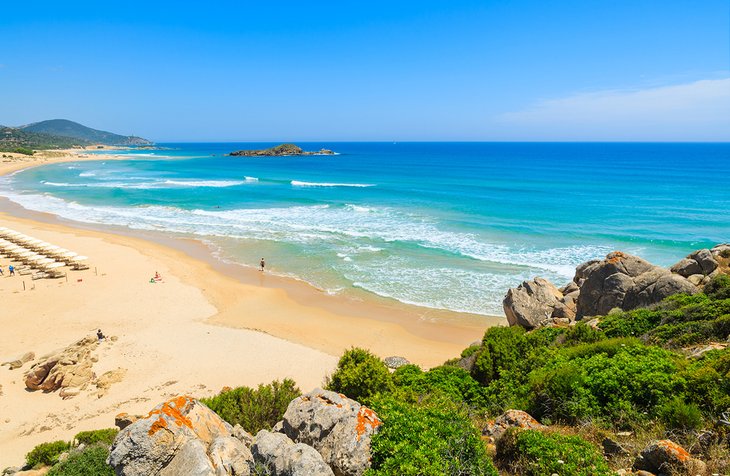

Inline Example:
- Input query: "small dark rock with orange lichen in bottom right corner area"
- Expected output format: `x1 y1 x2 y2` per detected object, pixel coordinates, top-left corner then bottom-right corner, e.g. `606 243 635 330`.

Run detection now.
634 440 706 476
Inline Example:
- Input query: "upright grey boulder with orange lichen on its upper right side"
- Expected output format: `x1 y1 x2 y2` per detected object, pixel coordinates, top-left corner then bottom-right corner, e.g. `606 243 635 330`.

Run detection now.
282 388 382 476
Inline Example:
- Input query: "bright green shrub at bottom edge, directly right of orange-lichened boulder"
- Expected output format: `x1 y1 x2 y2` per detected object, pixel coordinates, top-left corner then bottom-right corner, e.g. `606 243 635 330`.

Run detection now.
366 394 497 476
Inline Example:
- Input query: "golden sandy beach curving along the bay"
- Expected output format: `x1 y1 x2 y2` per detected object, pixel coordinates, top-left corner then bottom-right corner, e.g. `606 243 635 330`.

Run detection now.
0 151 494 468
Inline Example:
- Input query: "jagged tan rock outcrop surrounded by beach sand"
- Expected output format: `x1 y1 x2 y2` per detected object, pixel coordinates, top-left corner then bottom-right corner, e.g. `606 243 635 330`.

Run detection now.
25 336 97 397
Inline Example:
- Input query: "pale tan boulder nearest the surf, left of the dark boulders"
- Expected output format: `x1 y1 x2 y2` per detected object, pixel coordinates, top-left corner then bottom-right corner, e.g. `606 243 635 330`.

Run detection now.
502 278 578 329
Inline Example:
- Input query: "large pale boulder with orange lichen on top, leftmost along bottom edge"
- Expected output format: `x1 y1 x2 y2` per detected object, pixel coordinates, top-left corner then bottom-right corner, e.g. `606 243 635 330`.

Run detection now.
107 396 253 476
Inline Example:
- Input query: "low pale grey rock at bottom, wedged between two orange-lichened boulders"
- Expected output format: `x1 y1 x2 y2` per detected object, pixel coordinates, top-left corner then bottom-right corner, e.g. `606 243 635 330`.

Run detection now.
251 430 334 476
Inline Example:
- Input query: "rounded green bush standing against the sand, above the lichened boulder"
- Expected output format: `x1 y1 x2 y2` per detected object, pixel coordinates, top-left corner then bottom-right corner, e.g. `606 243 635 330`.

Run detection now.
325 348 393 401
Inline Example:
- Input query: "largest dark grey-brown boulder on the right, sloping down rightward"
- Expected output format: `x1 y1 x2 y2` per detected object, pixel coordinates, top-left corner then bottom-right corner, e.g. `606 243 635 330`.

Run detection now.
575 251 698 319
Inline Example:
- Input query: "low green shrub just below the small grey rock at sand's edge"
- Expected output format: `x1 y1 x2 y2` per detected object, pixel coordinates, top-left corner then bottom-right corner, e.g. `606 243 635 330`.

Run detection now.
393 365 486 408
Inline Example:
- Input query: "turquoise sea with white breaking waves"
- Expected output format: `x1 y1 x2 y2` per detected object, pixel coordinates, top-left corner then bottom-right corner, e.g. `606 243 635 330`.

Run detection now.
0 143 730 315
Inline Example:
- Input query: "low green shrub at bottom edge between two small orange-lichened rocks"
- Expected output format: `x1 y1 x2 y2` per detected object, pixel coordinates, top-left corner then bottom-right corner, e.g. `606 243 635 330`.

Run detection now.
496 428 614 476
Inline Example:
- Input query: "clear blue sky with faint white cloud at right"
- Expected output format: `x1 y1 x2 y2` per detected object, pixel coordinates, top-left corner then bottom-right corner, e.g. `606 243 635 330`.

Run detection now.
0 0 730 142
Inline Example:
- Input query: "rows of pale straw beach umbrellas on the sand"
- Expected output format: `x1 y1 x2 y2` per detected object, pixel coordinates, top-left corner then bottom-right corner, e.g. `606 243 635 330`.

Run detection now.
0 226 89 279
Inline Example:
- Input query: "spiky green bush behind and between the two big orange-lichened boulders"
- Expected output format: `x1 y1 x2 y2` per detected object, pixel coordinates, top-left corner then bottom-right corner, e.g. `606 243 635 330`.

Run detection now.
201 379 302 435
